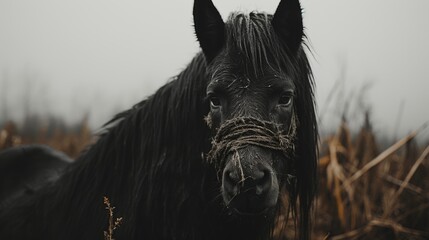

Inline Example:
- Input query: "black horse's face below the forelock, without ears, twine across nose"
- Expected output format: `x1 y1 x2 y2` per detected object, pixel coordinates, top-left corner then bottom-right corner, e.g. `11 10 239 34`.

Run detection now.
207 54 296 214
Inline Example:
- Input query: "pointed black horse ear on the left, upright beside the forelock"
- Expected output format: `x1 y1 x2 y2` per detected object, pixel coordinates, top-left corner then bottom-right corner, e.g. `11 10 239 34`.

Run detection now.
194 0 225 62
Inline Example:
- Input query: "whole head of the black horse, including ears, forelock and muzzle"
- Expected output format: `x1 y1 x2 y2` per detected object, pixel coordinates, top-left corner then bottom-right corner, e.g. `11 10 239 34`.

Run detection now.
194 0 302 215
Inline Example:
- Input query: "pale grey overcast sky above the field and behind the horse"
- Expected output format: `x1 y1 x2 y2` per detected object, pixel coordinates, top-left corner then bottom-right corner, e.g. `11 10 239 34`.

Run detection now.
0 0 429 138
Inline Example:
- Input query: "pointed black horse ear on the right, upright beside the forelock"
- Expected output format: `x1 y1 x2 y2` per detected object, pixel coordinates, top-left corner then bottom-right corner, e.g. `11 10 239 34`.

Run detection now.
271 0 304 53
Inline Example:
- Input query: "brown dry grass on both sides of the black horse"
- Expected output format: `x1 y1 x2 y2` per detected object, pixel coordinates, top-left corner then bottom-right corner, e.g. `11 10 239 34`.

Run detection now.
0 116 429 240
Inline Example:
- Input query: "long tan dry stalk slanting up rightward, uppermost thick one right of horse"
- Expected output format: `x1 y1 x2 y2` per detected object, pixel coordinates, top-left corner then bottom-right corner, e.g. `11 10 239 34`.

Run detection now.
344 131 418 186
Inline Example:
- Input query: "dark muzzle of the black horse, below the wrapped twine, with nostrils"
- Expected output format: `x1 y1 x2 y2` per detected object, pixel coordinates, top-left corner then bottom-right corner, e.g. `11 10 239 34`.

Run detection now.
222 146 279 215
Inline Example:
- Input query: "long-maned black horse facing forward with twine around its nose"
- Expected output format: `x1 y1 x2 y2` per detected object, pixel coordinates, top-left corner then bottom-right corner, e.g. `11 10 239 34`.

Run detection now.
0 0 317 240
